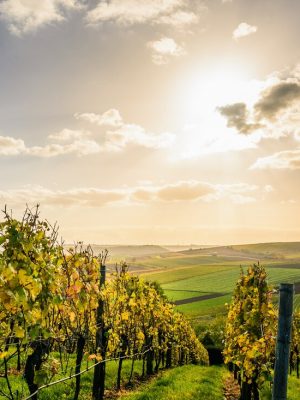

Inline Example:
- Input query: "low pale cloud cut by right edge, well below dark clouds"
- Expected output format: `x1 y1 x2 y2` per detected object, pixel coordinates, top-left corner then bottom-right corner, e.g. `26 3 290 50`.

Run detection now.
250 149 300 170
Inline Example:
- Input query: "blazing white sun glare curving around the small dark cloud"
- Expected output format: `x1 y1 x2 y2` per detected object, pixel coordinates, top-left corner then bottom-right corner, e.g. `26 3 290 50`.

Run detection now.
171 64 262 158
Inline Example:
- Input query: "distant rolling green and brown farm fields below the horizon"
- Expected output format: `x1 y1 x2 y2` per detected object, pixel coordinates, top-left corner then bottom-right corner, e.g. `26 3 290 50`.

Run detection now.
105 242 300 319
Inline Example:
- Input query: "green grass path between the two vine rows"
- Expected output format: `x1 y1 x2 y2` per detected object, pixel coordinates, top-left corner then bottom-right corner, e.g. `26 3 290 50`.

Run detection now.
121 365 225 400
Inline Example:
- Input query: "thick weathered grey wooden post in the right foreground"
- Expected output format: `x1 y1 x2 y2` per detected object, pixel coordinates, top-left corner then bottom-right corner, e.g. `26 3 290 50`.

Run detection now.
272 283 294 400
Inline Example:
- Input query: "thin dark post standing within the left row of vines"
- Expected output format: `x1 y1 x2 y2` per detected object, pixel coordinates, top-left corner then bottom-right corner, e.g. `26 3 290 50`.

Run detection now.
93 251 107 400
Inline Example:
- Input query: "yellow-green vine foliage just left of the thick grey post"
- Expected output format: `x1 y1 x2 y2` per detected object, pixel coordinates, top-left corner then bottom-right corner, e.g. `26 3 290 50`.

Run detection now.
224 265 277 400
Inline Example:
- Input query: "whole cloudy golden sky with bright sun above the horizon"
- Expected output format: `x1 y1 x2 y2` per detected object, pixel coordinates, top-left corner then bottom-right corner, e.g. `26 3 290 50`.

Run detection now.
0 0 300 244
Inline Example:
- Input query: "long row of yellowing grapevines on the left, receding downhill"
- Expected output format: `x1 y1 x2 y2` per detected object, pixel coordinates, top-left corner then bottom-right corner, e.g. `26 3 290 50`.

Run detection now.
0 208 208 400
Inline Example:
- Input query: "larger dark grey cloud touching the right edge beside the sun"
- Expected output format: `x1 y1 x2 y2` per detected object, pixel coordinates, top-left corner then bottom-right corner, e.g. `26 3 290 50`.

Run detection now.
254 82 300 120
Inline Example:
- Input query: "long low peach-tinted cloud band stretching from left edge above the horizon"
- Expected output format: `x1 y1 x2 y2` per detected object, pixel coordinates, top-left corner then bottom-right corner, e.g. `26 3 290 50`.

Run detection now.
0 180 260 207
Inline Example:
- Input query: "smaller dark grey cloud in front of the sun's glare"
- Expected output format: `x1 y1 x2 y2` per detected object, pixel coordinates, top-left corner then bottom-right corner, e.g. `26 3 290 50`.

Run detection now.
218 103 261 135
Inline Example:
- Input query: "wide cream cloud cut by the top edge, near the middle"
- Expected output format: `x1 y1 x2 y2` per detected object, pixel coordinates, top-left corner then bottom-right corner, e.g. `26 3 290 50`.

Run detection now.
86 0 204 26
